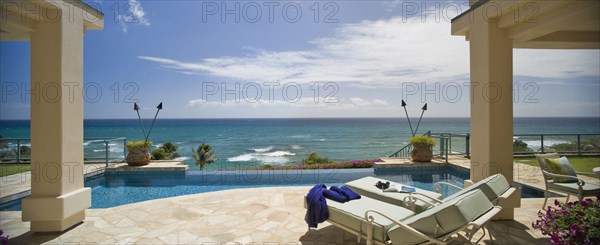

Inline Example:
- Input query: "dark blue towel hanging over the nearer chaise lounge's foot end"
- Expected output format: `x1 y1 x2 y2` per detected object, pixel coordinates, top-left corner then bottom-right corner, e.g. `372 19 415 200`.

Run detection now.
304 184 329 228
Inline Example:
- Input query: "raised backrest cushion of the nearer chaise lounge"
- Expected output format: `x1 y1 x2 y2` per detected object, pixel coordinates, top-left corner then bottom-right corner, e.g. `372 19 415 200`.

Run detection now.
390 190 493 244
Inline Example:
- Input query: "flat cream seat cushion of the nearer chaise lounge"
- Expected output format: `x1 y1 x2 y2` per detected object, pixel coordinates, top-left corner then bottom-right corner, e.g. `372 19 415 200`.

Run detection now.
327 196 414 242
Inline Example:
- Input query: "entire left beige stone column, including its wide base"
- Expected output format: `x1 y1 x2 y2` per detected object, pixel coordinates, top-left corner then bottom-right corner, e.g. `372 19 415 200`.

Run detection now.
23 4 91 232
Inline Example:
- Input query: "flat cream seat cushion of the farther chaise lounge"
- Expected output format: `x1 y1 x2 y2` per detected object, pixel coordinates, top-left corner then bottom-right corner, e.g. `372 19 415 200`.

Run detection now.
346 176 442 212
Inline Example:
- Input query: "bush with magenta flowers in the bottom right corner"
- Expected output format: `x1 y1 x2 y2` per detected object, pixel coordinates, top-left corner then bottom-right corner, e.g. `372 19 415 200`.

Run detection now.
531 195 600 245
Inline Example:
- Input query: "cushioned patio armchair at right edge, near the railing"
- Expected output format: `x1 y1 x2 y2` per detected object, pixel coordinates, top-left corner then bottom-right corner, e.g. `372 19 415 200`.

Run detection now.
535 153 600 208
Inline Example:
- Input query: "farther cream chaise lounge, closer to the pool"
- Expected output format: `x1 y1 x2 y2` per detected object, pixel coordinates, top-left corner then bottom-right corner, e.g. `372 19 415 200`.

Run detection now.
346 174 518 212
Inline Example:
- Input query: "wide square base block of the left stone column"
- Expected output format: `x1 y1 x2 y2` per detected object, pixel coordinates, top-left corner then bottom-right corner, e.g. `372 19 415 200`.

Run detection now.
22 188 92 232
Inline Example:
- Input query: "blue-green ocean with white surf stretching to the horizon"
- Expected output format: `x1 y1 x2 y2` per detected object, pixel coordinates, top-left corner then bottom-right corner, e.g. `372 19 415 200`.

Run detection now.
0 118 600 169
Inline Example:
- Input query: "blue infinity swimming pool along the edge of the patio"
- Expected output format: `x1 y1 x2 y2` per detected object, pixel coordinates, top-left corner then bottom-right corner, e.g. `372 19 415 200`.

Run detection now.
0 166 544 211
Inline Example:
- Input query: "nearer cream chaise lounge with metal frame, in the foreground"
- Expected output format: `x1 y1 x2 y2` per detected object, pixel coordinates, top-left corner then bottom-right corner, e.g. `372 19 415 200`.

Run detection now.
305 190 502 244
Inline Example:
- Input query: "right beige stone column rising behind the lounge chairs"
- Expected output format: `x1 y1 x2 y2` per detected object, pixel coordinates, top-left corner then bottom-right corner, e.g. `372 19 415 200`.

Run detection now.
465 19 520 219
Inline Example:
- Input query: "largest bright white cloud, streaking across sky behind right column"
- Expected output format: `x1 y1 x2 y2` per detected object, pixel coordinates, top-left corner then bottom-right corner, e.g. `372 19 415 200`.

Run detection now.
139 17 600 87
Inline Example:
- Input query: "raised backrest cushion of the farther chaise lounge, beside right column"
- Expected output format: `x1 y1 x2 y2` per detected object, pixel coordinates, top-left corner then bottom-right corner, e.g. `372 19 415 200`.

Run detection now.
444 174 511 202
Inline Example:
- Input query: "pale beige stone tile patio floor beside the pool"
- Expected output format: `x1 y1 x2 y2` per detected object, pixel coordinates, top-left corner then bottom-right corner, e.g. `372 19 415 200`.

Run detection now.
0 187 564 244
